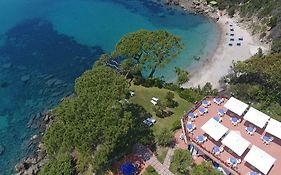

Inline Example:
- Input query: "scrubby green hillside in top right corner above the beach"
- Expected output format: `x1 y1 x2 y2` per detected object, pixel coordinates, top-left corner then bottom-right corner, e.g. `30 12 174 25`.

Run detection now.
212 0 281 53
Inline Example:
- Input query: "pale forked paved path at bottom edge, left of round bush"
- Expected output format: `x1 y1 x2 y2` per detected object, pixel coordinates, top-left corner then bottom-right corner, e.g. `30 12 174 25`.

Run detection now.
135 145 174 175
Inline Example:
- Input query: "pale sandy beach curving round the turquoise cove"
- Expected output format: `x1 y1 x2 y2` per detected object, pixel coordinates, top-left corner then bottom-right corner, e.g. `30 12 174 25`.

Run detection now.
182 15 268 88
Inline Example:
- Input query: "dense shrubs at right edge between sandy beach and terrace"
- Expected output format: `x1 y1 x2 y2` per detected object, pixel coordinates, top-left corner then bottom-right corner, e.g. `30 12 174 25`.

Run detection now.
227 54 281 120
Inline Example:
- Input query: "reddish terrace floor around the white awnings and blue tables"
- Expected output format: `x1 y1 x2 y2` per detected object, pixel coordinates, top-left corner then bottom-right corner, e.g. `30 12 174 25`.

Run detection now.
180 97 281 175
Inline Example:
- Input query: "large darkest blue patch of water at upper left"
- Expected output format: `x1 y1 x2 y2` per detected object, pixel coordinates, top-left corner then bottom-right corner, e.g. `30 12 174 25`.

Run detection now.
0 19 103 81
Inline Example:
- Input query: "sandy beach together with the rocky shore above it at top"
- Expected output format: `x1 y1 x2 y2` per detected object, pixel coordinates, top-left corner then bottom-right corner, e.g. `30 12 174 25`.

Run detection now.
166 0 270 90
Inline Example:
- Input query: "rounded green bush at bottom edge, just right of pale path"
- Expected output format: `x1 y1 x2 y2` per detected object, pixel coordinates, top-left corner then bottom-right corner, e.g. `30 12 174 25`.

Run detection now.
170 149 192 175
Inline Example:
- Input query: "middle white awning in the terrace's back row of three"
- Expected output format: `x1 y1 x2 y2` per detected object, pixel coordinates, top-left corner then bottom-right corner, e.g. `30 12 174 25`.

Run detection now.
244 107 270 128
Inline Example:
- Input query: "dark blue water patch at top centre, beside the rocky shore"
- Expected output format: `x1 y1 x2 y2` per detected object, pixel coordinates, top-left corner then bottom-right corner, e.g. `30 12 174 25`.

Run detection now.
100 0 208 30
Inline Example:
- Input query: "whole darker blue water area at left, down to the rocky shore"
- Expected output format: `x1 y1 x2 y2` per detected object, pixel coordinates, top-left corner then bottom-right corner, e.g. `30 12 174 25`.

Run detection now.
0 19 103 175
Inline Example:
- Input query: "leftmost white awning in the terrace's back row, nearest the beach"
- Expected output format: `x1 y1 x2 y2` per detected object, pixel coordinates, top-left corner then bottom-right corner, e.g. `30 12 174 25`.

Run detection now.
224 97 249 116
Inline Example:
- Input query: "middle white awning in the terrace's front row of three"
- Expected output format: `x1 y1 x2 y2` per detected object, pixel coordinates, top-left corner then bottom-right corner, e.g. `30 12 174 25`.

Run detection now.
222 131 250 156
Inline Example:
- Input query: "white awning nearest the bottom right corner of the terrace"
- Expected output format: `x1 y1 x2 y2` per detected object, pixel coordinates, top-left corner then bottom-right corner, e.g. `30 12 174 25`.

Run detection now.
244 145 276 174
